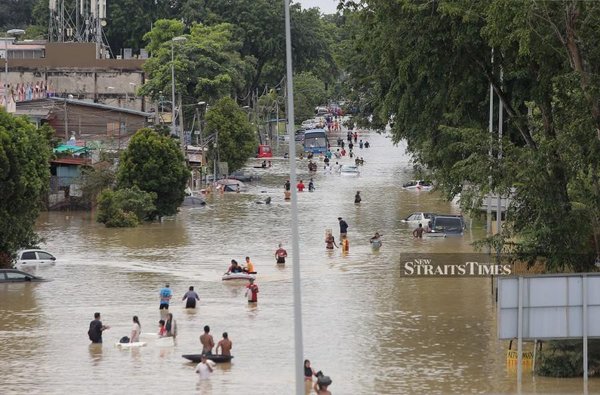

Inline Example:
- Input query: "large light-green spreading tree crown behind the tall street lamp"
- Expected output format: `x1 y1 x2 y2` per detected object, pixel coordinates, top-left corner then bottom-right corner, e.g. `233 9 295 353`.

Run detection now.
140 20 252 102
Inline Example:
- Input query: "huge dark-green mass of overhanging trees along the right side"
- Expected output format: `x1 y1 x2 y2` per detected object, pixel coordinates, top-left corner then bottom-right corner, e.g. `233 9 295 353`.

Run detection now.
342 0 600 271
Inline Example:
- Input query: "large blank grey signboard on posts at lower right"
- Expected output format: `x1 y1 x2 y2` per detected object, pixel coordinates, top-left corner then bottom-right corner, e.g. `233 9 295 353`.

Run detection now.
498 273 600 340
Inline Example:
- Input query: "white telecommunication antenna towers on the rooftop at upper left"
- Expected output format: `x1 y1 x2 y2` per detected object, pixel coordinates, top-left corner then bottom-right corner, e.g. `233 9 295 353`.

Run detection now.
48 0 111 59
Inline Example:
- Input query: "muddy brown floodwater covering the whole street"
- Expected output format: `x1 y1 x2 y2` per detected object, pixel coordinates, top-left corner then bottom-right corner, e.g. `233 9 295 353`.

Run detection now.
0 134 600 394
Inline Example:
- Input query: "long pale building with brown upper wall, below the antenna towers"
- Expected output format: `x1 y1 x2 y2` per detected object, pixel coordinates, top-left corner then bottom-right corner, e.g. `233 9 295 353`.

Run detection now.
0 39 146 112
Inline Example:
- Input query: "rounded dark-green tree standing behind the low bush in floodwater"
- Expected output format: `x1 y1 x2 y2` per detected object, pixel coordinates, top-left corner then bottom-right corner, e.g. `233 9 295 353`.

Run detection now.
117 128 190 216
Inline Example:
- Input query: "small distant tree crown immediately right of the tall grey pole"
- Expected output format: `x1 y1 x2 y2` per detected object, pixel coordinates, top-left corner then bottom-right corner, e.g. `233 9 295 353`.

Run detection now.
294 72 327 122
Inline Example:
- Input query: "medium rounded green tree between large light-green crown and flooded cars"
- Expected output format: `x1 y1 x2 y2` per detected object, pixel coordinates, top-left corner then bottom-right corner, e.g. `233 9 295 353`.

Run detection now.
205 97 257 171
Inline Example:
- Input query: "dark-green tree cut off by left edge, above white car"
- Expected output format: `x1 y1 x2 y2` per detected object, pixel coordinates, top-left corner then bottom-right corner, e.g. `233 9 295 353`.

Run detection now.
0 109 51 266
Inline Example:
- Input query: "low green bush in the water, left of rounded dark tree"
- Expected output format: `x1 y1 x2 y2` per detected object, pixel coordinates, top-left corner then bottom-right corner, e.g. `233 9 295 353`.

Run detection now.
96 186 156 228
